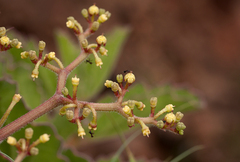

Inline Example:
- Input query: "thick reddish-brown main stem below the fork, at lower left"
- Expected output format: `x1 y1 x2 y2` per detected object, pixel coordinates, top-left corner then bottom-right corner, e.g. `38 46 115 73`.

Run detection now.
0 94 63 141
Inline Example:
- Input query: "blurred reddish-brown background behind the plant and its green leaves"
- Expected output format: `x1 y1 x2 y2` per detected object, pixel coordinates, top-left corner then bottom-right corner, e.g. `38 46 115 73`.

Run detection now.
0 0 240 162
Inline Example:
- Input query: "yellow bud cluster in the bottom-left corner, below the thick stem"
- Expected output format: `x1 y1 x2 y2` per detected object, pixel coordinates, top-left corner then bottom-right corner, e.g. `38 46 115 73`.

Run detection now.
7 128 50 156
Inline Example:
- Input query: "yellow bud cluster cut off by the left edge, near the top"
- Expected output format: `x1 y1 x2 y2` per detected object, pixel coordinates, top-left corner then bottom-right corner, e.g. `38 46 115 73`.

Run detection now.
0 27 22 51
